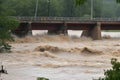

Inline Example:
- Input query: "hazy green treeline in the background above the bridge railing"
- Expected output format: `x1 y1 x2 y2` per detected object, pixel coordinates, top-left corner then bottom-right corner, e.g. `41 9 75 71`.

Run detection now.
5 0 120 18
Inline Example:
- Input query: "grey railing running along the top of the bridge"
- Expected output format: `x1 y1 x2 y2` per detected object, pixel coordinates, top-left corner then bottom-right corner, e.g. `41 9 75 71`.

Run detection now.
16 17 120 22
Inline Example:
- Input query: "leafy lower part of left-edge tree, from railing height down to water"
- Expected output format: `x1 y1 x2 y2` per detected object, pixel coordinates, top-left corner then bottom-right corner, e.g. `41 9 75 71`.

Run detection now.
0 16 19 53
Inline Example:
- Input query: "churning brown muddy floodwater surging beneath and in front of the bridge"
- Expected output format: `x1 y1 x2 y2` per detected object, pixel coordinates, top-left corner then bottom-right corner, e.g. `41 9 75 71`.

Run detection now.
0 32 120 80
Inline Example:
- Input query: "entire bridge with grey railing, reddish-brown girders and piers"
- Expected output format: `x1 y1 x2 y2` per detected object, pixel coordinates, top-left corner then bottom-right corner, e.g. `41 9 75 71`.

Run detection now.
12 17 120 40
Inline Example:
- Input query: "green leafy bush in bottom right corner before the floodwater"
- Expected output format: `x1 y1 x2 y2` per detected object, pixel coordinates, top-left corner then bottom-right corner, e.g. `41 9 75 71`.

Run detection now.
99 58 120 80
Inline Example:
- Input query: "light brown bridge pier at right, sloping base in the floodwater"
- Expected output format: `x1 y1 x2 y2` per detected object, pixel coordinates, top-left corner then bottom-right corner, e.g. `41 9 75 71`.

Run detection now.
81 22 102 40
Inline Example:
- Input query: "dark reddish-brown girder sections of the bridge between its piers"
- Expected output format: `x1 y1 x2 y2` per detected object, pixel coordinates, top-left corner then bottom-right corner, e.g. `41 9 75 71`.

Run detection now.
31 22 120 30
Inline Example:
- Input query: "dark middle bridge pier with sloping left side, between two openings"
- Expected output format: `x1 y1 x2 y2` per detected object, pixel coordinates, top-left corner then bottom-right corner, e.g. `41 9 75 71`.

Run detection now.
48 23 68 35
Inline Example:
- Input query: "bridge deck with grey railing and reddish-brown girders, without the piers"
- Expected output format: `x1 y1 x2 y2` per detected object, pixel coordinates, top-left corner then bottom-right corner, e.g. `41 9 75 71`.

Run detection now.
17 17 120 30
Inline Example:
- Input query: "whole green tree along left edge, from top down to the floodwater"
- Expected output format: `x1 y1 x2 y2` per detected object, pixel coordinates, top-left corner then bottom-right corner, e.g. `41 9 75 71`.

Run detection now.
0 0 19 53
